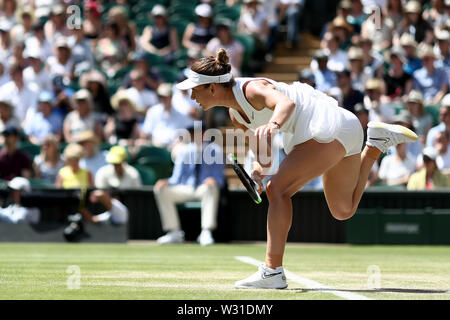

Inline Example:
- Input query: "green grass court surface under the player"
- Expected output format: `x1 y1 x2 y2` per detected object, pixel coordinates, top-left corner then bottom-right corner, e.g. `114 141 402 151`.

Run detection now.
0 243 450 300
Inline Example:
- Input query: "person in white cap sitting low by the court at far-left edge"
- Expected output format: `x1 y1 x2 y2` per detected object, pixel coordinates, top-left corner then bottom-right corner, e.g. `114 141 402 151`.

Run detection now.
0 177 41 224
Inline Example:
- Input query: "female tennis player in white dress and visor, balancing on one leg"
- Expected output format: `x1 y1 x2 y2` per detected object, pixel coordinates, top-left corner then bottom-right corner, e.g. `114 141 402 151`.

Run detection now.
177 49 418 289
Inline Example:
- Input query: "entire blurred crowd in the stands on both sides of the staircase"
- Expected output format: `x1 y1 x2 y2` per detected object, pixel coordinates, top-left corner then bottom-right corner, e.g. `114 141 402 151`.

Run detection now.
0 0 450 192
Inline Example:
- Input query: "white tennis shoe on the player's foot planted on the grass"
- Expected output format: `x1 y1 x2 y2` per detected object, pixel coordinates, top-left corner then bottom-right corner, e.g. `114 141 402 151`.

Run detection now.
234 263 287 289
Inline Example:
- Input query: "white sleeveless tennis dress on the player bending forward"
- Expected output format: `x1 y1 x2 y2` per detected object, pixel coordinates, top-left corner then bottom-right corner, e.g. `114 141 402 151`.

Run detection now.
231 78 364 157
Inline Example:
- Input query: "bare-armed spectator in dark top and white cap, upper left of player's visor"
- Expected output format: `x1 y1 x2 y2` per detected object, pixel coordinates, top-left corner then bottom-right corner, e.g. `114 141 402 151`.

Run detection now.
140 5 178 64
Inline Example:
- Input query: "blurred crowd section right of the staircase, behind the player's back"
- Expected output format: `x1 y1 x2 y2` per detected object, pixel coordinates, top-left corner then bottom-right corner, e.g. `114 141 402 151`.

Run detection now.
299 0 450 190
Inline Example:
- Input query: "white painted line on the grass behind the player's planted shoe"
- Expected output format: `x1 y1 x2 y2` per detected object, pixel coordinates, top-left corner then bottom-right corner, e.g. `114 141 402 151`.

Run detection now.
234 256 373 300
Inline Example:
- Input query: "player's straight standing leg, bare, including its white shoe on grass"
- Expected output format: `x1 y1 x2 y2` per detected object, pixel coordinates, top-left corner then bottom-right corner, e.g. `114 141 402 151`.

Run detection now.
235 140 346 289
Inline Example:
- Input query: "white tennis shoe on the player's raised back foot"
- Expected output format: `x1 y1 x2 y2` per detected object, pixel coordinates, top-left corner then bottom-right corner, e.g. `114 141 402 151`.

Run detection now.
366 121 419 153
